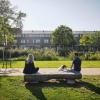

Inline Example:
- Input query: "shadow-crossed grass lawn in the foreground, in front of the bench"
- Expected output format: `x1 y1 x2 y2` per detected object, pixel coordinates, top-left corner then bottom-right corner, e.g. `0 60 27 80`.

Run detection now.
0 76 100 100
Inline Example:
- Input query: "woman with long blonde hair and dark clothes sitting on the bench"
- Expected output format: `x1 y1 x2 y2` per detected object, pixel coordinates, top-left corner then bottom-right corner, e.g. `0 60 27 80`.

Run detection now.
23 54 39 74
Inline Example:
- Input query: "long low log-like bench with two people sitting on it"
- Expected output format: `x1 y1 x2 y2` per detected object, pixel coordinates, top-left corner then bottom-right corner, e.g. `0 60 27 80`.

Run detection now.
24 71 82 84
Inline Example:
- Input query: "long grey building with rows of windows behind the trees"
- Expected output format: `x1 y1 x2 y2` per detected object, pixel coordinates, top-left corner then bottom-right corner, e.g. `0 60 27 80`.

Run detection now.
15 31 93 48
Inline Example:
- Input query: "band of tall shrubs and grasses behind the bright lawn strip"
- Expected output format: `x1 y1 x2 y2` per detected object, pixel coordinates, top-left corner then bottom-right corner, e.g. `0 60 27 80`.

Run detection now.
0 49 100 60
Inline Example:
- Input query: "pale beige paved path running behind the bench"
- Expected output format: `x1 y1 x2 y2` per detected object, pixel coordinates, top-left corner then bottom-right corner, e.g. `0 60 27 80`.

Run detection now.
0 68 100 76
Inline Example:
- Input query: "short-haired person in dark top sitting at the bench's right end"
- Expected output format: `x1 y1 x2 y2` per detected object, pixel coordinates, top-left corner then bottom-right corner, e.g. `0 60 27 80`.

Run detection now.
71 53 81 72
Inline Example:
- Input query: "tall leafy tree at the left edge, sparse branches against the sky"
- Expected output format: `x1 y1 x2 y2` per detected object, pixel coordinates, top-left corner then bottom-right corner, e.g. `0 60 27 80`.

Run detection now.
0 0 26 42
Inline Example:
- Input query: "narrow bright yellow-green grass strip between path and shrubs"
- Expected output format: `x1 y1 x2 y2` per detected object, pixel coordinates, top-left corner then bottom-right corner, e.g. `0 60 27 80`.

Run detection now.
0 61 100 68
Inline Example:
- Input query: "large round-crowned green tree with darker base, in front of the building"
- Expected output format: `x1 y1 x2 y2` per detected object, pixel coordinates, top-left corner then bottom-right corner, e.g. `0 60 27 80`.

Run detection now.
51 25 75 56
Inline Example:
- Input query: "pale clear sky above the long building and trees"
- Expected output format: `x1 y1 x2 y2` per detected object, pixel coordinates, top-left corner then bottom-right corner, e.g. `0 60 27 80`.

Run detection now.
10 0 100 31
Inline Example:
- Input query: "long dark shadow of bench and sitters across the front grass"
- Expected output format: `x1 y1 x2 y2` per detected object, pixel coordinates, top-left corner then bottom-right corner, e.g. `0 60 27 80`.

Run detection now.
25 80 100 100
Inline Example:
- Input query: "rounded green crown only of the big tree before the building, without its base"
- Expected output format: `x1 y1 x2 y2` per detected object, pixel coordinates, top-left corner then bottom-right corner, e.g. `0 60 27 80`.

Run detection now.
52 25 75 46
